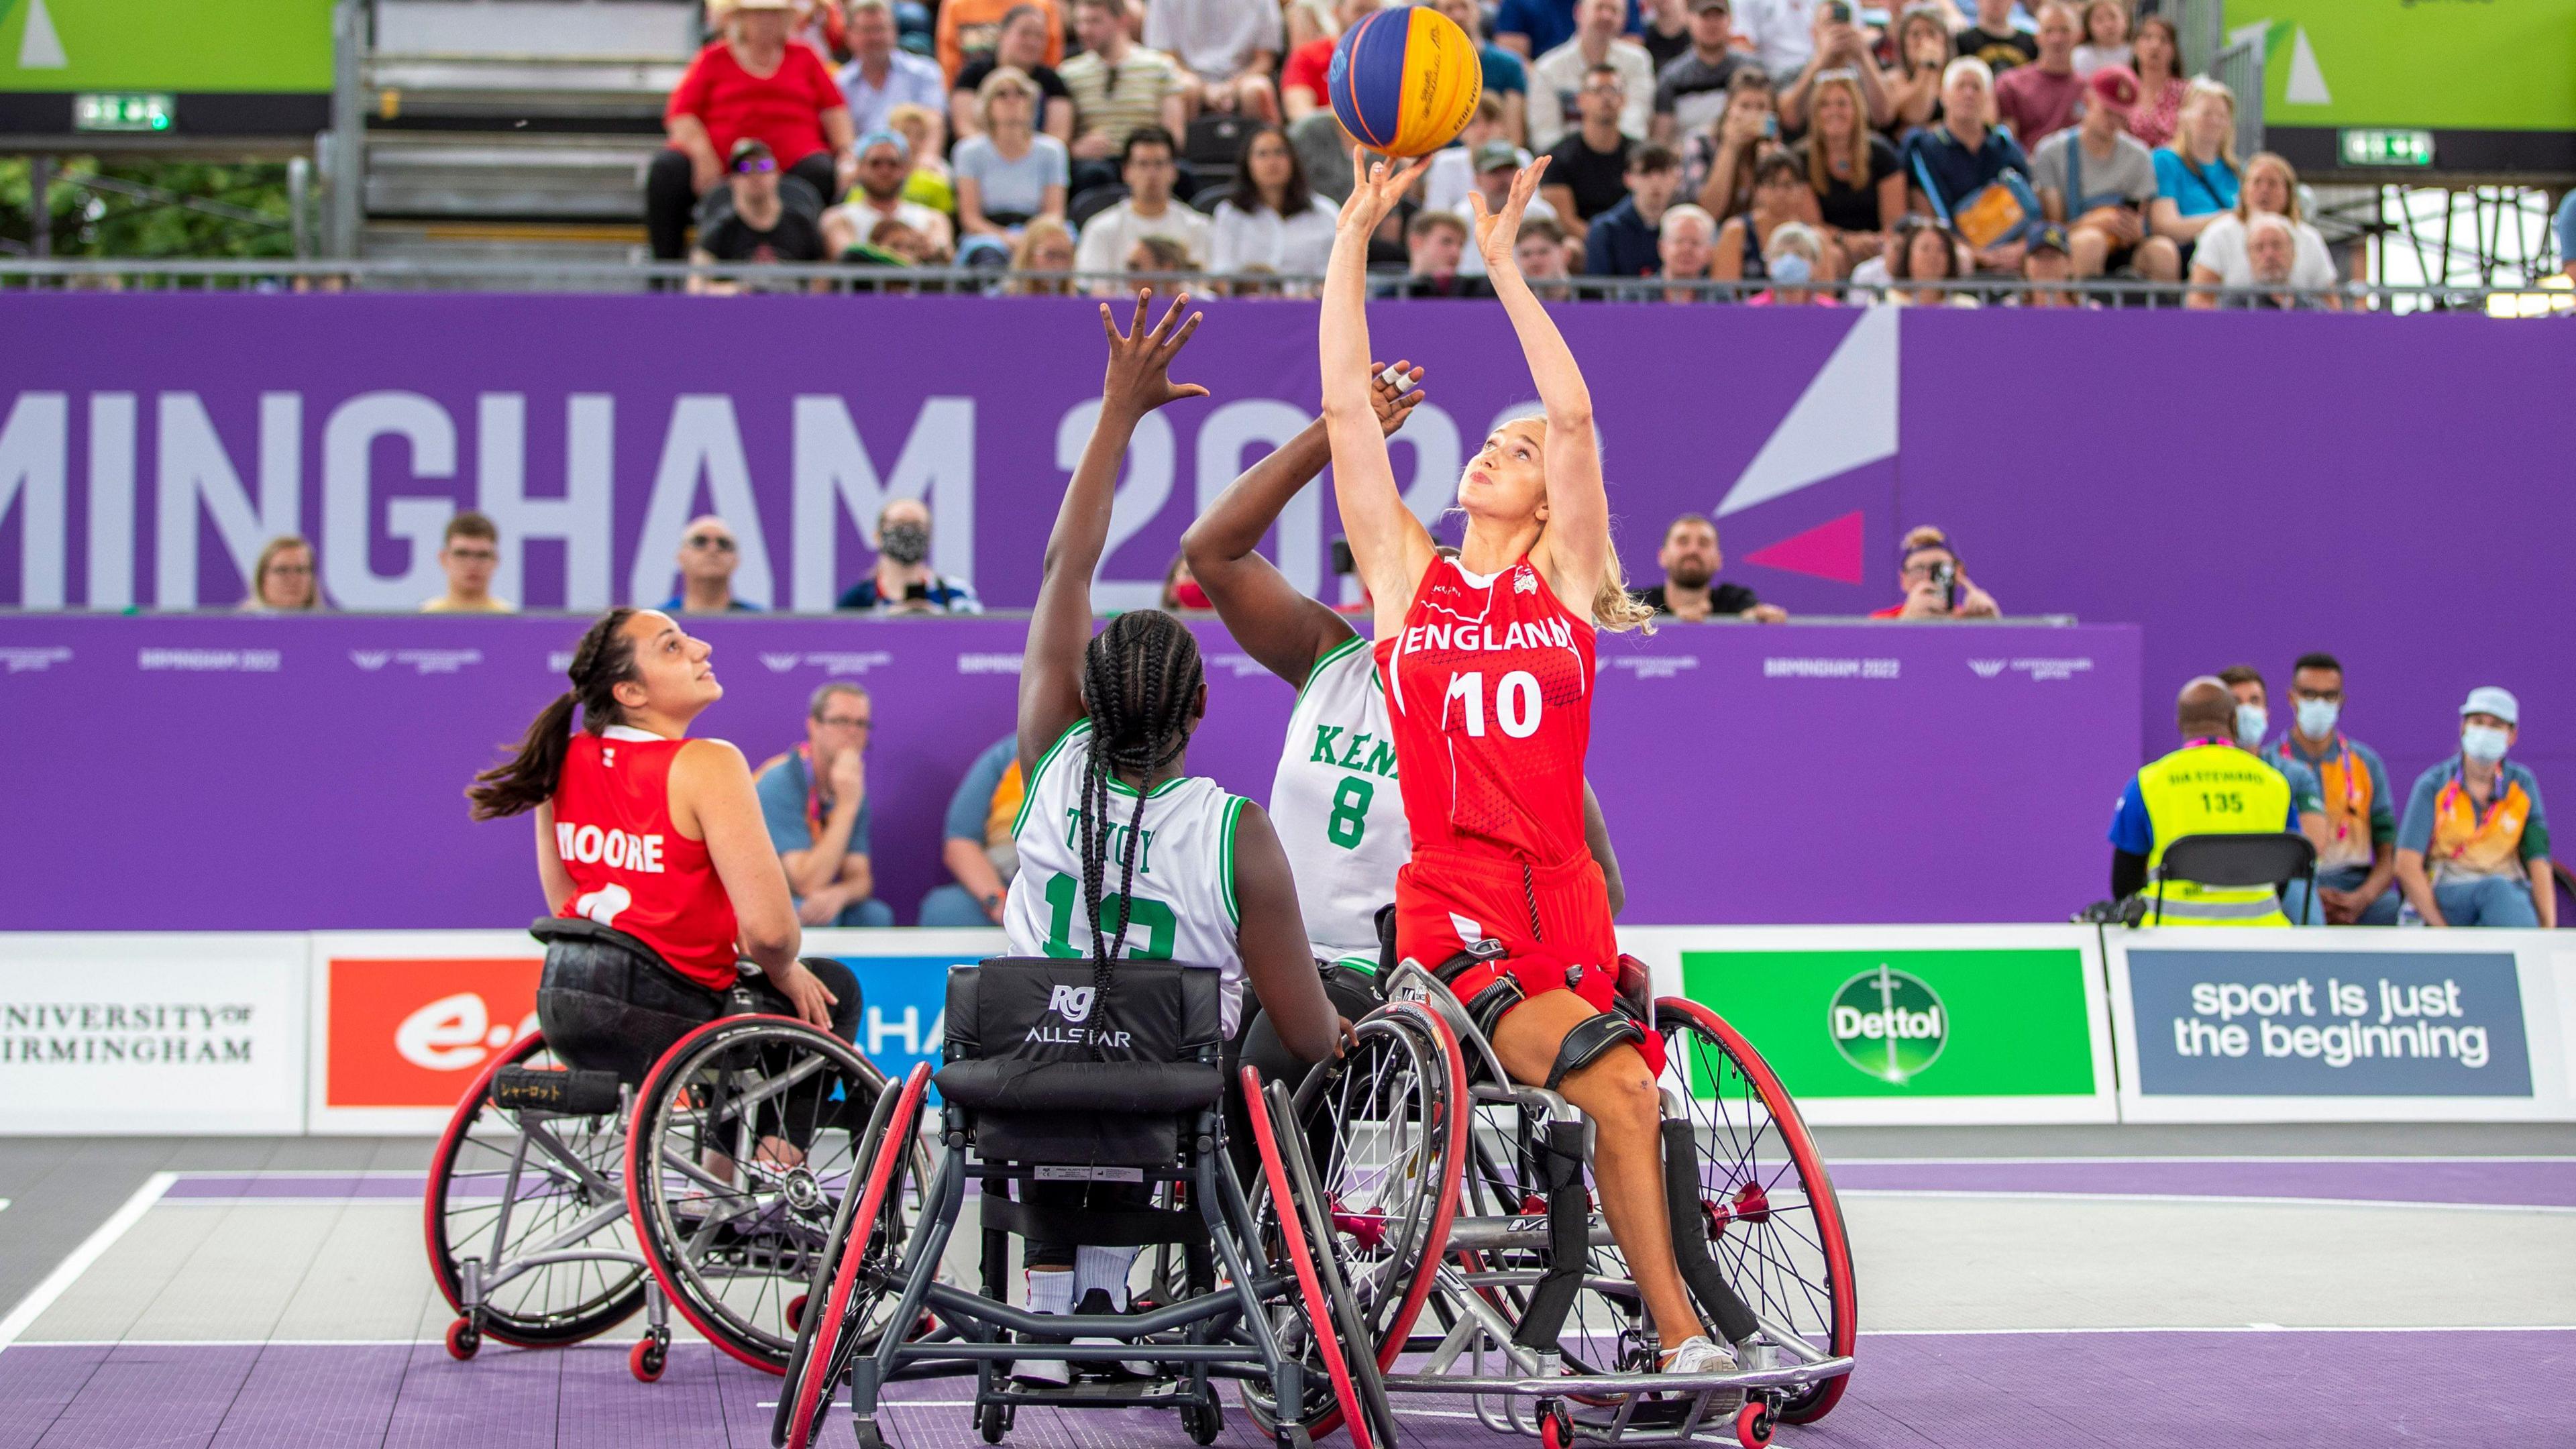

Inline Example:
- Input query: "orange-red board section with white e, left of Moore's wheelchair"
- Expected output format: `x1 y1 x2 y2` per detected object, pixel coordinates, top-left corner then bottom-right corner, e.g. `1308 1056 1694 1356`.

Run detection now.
309 930 543 1132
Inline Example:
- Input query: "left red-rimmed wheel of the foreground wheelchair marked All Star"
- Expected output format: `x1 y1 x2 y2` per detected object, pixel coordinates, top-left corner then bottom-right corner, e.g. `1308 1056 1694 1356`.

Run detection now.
770 1062 937 1449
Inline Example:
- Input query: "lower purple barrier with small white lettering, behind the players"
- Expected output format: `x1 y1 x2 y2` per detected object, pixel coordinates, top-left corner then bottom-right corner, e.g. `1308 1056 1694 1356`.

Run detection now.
0 614 2138 930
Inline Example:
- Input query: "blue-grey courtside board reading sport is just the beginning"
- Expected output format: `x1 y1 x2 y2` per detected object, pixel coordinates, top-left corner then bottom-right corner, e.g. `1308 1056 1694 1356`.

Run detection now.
2104 926 2576 1122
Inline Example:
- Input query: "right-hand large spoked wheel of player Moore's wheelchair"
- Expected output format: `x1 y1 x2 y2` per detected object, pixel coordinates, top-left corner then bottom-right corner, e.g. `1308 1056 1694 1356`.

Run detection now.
626 1016 886 1375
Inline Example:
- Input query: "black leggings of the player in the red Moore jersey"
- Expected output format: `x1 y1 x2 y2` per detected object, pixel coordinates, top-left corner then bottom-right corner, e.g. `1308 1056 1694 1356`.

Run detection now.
536 928 861 1083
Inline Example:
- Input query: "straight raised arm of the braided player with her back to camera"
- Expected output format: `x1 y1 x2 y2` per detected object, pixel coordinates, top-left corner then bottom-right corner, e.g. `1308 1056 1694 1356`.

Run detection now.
1020 286 1208 773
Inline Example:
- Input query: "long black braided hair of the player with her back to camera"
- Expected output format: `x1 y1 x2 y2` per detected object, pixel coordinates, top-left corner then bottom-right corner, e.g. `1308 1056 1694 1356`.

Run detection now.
1079 608 1205 990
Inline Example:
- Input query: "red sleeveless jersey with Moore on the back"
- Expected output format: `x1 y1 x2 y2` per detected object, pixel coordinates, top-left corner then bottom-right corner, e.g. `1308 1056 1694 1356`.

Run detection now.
554 727 741 990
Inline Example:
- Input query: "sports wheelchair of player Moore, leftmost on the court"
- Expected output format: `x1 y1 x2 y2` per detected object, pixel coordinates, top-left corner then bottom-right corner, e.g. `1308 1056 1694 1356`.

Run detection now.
423 918 894 1382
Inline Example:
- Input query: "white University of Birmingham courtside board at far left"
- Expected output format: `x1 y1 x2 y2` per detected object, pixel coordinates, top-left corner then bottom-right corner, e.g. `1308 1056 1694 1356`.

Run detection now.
0 933 307 1134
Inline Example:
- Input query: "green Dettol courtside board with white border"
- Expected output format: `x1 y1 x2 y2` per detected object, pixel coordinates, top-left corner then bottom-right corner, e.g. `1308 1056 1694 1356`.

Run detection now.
1620 926 2117 1127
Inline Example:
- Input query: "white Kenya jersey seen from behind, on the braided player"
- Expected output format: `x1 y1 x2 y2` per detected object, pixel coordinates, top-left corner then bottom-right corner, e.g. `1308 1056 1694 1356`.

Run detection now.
1002 719 1244 1036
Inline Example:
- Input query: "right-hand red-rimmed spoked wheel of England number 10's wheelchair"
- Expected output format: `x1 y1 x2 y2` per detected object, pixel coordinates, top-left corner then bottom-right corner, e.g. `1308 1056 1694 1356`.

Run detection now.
1654 996 1860 1424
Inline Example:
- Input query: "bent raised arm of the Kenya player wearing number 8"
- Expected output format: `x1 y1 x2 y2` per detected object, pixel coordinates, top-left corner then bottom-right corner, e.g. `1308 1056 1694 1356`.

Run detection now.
1180 361 1422 688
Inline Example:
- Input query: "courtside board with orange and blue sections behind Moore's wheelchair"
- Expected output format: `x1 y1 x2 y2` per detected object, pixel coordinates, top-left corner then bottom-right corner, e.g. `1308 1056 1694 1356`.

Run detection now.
292 930 1005 1134
